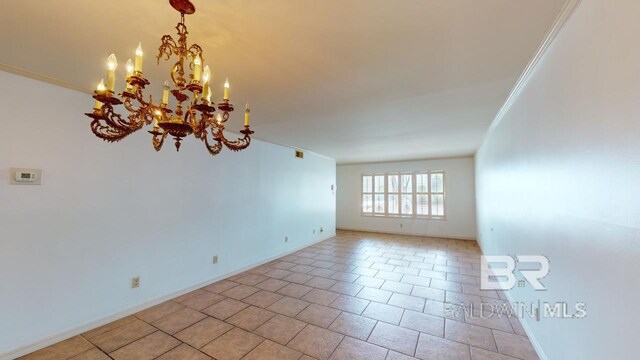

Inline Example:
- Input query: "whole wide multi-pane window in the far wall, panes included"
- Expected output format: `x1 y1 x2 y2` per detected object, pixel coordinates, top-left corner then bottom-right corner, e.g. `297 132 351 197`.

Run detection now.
362 171 445 218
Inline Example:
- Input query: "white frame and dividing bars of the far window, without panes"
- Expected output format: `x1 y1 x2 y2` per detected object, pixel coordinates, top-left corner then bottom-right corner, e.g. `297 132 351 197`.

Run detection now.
360 170 448 220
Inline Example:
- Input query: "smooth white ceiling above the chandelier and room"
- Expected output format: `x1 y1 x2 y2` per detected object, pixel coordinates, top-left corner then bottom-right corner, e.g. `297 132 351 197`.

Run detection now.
0 0 565 163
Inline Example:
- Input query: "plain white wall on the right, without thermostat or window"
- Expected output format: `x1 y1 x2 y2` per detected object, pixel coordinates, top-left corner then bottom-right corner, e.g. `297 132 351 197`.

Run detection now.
476 0 640 360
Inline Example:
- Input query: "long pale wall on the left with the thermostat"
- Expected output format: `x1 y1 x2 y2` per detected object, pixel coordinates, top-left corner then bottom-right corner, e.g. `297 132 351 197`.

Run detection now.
0 72 335 358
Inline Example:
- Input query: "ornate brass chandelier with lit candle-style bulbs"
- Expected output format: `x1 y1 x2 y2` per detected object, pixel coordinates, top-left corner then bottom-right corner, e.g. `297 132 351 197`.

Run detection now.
85 0 253 155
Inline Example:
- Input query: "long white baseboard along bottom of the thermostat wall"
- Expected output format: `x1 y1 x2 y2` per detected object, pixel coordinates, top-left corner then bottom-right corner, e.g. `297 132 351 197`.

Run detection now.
0 233 335 360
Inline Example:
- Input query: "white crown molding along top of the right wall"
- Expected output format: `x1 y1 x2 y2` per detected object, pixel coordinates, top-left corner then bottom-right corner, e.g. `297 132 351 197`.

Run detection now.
476 0 582 153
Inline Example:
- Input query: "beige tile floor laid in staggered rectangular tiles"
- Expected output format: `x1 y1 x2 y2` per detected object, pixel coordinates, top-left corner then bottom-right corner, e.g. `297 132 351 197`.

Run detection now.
22 231 538 360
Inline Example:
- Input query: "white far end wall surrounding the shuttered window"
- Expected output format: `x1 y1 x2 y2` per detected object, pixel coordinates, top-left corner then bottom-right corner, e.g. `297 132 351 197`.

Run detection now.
336 157 476 239
